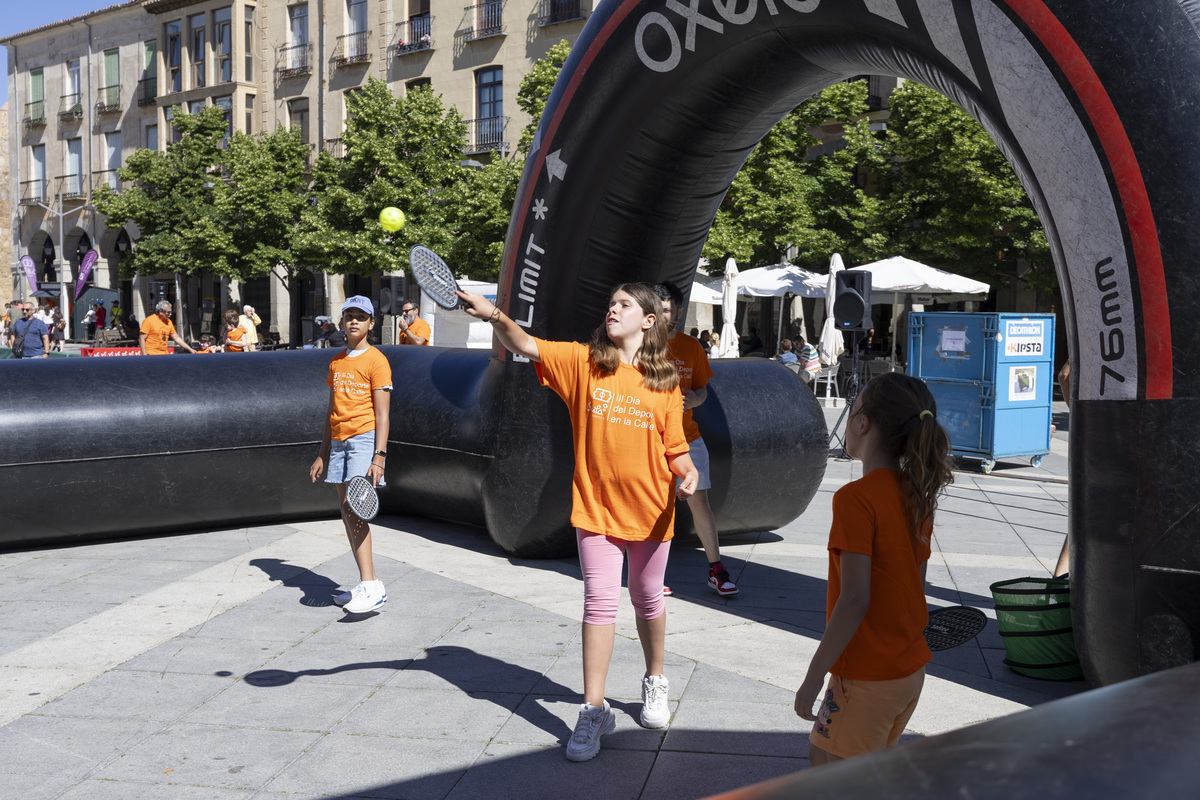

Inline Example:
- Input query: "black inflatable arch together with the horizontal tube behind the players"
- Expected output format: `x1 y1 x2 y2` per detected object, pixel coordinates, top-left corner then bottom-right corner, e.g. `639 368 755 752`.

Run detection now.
0 0 1200 682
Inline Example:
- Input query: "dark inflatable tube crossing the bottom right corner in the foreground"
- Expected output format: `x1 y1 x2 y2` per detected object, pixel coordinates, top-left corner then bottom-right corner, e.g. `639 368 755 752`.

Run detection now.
705 664 1200 800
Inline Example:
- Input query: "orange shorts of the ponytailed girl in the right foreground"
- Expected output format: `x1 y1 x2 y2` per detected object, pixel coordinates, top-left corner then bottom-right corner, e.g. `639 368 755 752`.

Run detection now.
809 667 925 758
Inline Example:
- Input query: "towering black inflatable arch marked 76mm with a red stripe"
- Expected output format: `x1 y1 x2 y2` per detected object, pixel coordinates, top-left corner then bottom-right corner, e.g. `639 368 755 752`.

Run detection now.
497 0 1200 682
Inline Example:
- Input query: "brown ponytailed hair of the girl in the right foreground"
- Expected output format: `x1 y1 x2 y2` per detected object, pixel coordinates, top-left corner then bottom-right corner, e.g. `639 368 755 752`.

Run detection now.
859 372 954 539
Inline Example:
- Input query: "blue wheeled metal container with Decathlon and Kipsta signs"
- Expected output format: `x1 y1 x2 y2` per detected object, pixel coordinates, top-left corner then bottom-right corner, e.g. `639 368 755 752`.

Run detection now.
908 312 1055 473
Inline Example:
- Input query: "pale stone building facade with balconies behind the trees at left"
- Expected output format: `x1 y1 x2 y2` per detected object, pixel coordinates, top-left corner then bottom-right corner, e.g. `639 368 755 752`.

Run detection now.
0 0 594 342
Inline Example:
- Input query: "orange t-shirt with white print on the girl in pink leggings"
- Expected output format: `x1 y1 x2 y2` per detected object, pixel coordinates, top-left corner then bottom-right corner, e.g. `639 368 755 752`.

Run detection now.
538 339 688 542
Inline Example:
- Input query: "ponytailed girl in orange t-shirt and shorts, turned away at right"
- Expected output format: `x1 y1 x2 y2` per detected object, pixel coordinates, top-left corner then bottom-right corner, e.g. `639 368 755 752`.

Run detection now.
796 372 952 766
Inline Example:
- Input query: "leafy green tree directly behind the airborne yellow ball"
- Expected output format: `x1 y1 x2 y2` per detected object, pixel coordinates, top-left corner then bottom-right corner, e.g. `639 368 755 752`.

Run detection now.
295 78 468 275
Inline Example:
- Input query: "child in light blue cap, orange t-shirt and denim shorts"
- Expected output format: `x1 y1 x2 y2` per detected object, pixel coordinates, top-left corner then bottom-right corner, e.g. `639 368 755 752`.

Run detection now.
308 295 391 614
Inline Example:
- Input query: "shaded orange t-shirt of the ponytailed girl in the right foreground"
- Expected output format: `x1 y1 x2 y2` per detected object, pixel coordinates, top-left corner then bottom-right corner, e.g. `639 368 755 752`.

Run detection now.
826 469 932 680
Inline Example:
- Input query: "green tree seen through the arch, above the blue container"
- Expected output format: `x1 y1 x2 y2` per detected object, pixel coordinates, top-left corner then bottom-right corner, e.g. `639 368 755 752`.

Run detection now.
880 83 1056 290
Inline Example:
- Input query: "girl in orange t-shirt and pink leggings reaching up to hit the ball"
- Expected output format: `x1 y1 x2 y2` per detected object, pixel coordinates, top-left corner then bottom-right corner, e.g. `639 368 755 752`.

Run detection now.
458 283 698 762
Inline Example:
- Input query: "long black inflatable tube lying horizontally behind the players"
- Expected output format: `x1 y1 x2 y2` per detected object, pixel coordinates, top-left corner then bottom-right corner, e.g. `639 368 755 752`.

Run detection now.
0 348 826 557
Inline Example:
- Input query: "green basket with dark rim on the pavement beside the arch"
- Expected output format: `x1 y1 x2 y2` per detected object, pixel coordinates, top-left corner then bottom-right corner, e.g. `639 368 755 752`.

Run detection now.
991 578 1084 680
